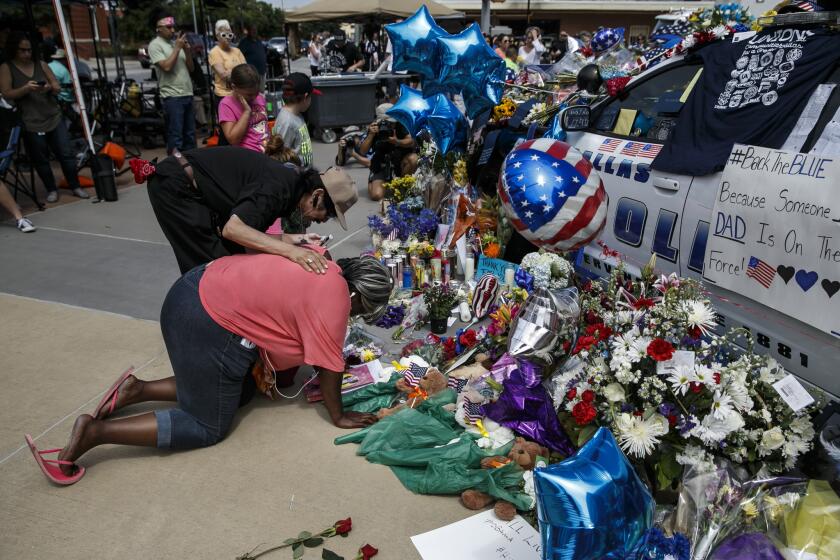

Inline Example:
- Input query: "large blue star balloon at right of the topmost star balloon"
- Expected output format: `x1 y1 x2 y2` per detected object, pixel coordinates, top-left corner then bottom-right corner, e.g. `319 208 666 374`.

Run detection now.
437 23 505 118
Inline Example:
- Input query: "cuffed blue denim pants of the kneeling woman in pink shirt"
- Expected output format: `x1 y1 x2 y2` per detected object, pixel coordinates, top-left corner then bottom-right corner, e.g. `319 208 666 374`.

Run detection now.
155 265 258 449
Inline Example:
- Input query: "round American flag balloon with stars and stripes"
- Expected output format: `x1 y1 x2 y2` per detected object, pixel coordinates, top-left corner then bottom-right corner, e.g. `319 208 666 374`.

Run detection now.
499 138 607 253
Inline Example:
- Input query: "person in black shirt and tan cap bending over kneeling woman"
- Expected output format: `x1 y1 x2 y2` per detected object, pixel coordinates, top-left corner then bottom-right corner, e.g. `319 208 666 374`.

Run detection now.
144 146 359 274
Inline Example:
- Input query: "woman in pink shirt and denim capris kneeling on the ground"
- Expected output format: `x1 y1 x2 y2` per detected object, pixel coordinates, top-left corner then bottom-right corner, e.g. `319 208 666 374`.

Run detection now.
27 254 392 484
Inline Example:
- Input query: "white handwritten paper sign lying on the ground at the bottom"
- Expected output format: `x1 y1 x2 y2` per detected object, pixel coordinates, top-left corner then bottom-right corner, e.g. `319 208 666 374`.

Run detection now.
411 510 542 560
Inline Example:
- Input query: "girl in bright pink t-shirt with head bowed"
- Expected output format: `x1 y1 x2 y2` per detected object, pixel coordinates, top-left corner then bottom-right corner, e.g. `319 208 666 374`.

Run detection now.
219 64 268 152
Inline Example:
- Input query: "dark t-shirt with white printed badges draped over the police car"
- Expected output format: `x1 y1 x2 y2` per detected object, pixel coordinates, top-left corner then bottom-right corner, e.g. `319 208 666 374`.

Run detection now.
651 28 840 175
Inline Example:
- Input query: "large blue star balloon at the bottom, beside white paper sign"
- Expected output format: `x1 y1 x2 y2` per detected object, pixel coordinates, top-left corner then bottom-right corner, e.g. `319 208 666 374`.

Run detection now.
534 428 654 560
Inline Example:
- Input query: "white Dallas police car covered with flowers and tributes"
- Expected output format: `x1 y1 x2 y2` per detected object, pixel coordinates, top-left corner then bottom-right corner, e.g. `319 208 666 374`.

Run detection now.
564 13 840 398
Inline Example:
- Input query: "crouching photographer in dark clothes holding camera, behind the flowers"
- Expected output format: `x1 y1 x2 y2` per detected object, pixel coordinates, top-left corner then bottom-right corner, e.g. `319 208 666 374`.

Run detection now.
357 103 418 201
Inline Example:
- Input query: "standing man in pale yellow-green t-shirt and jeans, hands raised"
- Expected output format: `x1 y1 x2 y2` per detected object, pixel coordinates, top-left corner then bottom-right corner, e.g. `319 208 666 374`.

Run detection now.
149 16 195 154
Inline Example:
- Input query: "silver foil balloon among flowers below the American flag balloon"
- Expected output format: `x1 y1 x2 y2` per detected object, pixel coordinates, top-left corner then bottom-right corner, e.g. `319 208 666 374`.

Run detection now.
508 288 580 365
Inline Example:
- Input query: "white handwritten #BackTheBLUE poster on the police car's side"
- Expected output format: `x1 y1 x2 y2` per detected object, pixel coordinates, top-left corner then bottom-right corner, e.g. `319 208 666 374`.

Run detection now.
703 144 840 337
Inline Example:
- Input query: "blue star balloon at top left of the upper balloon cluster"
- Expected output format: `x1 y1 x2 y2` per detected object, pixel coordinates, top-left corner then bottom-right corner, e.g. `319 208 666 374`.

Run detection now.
385 5 449 79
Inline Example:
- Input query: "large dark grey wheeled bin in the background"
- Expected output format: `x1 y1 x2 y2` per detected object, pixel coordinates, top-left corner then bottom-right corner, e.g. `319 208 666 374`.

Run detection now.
307 75 379 142
